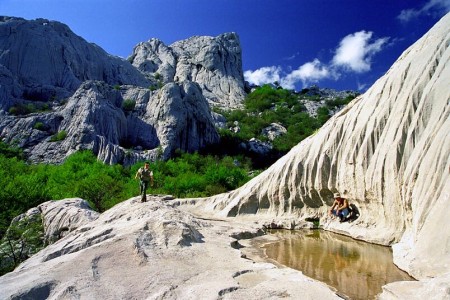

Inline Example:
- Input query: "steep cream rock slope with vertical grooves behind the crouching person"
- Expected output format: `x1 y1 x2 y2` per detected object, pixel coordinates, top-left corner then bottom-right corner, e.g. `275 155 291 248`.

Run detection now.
188 14 450 278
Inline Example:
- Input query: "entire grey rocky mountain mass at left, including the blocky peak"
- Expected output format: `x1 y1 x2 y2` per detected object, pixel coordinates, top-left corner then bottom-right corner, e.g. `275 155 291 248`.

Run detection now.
0 17 236 164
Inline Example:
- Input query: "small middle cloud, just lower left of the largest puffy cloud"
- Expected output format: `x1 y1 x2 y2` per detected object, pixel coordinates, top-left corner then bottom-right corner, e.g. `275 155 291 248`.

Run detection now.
280 58 331 89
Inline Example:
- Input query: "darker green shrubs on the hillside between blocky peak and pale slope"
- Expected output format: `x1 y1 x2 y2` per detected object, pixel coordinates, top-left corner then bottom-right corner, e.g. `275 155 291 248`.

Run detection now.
211 85 357 168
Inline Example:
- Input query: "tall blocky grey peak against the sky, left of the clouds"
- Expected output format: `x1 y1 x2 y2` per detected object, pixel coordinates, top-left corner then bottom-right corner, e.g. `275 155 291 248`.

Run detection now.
129 33 245 108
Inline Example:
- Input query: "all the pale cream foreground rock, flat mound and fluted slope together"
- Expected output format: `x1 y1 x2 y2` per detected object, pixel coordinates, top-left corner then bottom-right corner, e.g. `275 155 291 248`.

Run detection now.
0 14 450 299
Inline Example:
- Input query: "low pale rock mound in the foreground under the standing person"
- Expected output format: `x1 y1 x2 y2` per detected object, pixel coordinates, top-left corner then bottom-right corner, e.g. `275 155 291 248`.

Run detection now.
0 197 339 299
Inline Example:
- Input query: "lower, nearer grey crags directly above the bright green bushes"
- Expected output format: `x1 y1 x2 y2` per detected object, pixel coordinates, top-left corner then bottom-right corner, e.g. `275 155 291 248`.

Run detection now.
0 81 219 164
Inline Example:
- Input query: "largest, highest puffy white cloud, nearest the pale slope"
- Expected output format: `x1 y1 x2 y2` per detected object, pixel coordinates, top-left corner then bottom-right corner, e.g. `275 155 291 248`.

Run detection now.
332 30 388 73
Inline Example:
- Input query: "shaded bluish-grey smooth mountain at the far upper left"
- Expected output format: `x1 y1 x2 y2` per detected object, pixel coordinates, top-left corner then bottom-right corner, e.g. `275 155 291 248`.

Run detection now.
0 17 150 109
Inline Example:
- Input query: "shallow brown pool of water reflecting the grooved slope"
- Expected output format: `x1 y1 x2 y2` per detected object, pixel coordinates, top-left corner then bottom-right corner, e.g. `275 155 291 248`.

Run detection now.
263 230 414 299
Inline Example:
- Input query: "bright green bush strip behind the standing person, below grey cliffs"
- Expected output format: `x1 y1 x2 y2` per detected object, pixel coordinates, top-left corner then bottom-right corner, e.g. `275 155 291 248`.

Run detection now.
0 143 250 237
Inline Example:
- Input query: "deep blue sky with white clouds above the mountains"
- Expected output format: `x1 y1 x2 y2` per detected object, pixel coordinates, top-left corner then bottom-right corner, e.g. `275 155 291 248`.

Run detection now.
0 0 450 92
